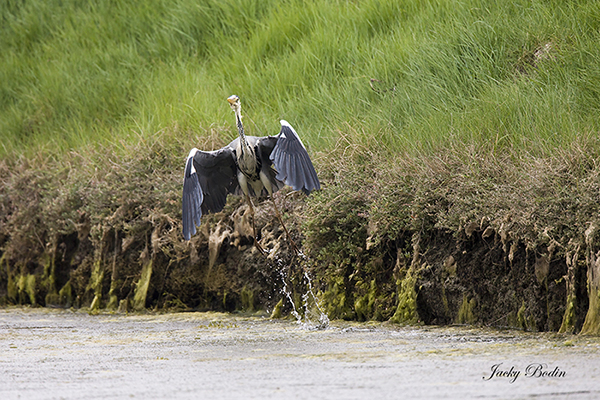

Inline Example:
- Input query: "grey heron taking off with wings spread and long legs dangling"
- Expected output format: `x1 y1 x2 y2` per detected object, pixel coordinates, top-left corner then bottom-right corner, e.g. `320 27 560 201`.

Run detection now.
182 95 321 254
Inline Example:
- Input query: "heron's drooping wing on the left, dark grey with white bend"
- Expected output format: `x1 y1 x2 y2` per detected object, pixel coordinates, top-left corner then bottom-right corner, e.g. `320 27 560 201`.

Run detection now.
181 146 239 240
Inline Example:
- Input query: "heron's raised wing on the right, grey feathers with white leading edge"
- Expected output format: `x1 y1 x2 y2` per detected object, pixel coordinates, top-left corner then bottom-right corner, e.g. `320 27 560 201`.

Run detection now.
270 120 321 193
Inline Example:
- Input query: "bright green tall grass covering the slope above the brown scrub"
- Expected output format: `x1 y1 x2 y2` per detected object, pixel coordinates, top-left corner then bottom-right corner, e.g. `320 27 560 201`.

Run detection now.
0 0 600 157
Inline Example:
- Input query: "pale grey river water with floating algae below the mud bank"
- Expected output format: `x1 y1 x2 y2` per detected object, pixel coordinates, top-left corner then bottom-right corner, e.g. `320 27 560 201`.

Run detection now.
0 308 600 399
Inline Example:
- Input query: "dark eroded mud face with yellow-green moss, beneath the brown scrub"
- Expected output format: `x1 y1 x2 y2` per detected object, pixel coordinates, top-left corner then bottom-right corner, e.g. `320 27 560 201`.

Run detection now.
0 193 600 333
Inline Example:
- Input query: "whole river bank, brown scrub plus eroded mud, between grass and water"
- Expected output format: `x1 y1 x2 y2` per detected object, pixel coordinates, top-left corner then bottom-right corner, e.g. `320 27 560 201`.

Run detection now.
0 143 600 334
